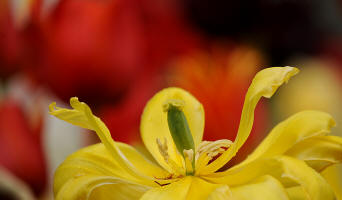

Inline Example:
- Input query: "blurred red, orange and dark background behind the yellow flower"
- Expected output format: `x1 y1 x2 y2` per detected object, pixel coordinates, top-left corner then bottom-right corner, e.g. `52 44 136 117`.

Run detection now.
0 0 342 199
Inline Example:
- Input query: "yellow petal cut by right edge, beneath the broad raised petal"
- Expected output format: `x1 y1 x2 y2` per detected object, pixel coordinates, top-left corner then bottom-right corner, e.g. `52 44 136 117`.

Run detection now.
286 136 342 172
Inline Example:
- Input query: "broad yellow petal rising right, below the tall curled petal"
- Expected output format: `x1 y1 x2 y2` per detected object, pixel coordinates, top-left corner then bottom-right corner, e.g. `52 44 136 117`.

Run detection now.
242 111 335 164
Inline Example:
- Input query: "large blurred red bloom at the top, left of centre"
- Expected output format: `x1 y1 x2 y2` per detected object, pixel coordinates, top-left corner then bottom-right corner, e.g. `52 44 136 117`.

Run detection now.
4 0 199 105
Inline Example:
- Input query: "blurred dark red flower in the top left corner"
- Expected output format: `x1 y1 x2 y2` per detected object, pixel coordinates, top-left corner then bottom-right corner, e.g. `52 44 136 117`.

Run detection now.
0 0 41 78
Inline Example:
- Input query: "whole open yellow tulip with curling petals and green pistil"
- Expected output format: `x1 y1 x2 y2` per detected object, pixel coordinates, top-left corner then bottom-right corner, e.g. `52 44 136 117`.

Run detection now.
50 67 342 200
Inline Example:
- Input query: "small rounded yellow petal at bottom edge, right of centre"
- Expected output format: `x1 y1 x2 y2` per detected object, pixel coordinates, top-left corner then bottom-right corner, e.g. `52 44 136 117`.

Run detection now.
231 175 289 200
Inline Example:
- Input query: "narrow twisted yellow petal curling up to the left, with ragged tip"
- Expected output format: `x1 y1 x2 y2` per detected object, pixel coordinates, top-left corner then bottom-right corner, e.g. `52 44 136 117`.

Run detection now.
49 97 159 184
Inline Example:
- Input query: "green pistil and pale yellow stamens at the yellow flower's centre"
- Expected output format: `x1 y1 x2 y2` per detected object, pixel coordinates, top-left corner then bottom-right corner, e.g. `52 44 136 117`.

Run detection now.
156 99 232 176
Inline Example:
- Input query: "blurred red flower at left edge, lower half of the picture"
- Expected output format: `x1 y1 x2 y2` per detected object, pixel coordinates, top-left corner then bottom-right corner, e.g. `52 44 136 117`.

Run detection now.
0 99 47 194
